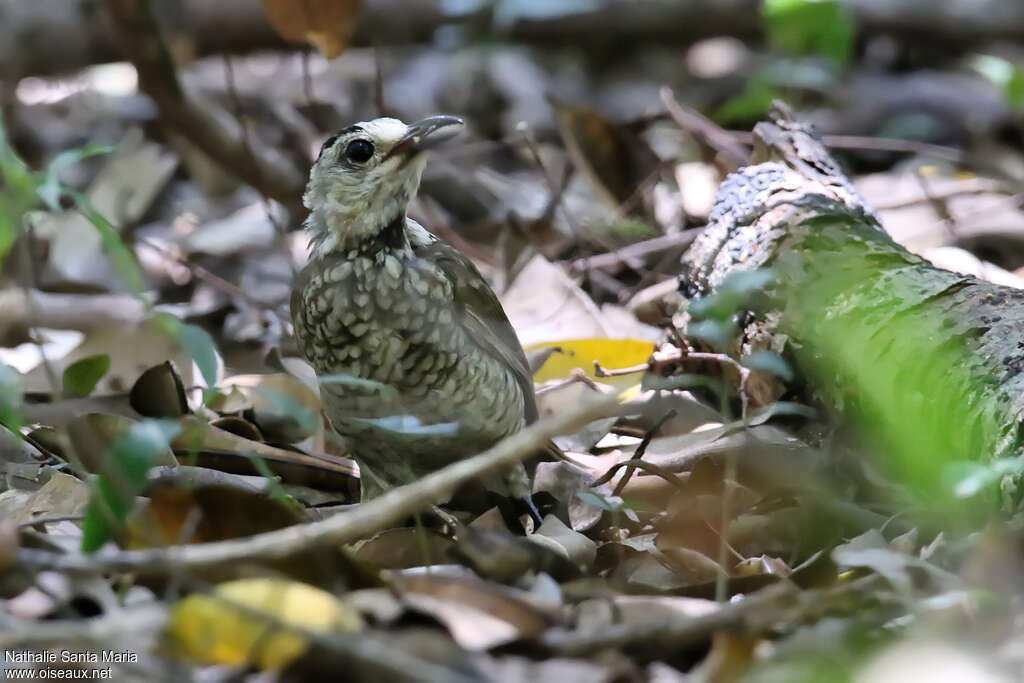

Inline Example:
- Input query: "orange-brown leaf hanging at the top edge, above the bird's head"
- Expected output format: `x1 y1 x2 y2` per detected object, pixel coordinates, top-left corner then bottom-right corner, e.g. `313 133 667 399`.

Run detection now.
263 0 360 59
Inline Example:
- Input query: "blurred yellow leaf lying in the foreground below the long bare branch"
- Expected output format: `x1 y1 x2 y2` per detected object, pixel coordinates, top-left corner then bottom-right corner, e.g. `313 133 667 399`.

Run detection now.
168 579 362 671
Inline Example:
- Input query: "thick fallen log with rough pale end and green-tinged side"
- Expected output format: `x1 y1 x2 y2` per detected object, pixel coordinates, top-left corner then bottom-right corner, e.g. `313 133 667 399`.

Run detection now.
682 107 1024 507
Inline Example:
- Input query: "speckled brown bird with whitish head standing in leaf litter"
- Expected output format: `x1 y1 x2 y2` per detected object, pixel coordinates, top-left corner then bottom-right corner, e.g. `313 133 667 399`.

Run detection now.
291 115 538 507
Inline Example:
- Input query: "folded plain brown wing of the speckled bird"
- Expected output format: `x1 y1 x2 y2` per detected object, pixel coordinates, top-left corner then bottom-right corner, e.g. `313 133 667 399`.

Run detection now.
412 239 538 424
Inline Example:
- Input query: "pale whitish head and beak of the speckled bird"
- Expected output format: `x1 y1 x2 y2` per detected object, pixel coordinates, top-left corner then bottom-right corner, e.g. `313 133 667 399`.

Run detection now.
302 116 463 249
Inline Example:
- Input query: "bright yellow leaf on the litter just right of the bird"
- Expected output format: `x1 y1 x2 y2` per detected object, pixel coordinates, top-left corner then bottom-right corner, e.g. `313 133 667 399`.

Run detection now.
526 339 654 384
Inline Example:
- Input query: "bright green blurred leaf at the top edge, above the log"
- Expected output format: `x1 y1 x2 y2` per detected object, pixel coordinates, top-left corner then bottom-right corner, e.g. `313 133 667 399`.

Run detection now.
762 0 855 65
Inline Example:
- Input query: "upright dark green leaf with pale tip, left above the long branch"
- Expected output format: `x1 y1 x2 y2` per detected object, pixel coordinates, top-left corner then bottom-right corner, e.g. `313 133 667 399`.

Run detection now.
82 420 181 553
